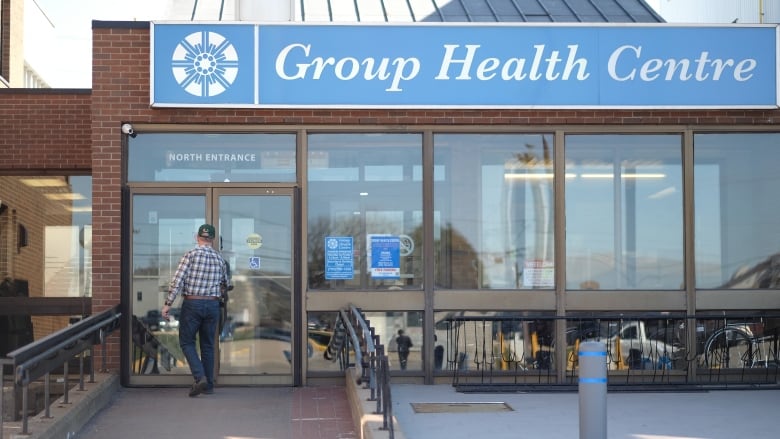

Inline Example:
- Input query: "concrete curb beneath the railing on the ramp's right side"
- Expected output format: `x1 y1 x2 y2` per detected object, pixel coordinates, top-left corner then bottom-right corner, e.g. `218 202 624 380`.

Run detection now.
345 367 406 439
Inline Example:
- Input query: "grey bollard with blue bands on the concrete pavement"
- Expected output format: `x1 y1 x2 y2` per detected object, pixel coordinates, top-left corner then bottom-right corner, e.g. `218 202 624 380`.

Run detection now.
578 341 607 439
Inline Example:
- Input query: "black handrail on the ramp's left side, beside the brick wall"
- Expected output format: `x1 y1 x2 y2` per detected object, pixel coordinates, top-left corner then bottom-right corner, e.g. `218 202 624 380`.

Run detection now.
0 305 121 439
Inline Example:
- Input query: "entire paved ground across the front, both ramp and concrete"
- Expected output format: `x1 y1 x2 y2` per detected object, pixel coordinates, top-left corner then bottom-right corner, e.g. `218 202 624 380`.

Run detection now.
3 374 780 439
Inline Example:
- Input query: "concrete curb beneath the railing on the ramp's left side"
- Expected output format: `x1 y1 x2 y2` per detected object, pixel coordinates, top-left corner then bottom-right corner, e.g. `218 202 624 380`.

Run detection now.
10 373 119 439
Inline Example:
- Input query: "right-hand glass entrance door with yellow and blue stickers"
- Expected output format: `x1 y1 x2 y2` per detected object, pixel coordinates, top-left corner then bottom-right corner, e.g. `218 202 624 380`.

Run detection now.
214 189 297 384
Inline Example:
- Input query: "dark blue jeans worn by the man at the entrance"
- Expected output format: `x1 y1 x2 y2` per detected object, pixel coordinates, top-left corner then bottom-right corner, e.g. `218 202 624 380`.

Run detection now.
179 299 219 389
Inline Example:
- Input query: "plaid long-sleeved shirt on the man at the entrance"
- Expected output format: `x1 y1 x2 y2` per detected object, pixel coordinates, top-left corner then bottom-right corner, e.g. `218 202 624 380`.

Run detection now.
168 245 230 303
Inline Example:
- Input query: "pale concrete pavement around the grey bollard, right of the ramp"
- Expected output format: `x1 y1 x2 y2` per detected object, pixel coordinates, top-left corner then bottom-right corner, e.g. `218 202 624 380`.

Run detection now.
392 384 780 439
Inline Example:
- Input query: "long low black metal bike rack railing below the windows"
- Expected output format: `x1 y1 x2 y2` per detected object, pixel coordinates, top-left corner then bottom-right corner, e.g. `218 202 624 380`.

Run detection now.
436 313 780 388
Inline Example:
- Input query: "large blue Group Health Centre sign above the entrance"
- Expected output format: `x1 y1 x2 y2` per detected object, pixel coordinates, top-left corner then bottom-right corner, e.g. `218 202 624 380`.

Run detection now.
151 23 778 108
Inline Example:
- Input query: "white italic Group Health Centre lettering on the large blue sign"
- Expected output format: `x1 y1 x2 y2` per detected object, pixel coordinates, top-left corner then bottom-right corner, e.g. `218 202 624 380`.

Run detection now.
276 43 756 92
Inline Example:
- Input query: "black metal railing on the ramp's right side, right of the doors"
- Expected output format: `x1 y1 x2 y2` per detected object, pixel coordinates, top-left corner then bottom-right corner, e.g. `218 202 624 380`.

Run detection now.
324 305 394 439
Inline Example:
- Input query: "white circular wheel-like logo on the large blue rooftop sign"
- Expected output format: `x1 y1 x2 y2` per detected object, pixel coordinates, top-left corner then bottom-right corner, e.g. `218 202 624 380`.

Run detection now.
171 31 238 97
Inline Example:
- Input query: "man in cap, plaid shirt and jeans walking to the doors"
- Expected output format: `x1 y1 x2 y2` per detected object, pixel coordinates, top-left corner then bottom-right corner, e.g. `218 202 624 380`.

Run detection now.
162 224 231 397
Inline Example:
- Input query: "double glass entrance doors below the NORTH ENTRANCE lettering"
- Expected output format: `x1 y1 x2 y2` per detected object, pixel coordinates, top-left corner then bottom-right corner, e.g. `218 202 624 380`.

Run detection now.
129 188 302 385
